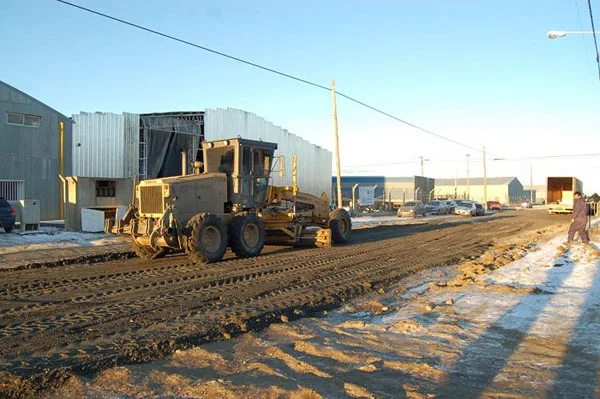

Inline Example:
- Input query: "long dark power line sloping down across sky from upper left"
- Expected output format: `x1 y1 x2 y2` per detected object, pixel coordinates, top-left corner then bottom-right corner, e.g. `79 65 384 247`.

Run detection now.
56 0 488 152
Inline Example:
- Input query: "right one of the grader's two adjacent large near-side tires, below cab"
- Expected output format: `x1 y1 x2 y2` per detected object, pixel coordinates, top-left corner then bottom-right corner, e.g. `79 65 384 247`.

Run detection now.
229 215 265 258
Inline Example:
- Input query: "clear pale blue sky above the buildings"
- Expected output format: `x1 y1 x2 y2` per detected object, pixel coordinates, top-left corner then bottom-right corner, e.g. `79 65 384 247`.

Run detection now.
0 0 600 193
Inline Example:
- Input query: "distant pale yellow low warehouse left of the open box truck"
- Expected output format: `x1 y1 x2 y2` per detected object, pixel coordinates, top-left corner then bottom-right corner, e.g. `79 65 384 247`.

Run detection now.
435 177 524 204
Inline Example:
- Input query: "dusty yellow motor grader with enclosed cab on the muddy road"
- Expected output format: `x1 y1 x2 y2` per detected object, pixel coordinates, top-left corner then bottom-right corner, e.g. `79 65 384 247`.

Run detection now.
105 138 352 263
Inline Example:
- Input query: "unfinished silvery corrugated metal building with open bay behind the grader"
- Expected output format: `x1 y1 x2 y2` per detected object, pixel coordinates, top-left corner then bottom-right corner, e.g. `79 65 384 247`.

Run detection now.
73 108 332 195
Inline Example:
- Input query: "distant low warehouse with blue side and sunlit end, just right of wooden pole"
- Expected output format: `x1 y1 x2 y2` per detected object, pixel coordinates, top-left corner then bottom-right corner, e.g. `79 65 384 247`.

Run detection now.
331 176 435 206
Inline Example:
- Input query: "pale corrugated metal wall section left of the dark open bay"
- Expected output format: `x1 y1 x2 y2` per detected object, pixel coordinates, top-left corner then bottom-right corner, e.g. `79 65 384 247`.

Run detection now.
73 112 140 178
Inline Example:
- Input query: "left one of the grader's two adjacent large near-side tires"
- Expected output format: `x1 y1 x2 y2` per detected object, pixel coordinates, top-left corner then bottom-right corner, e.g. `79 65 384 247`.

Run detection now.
188 215 227 264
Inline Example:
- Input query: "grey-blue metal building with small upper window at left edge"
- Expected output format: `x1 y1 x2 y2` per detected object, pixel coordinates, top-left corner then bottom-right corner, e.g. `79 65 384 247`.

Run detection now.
0 81 72 220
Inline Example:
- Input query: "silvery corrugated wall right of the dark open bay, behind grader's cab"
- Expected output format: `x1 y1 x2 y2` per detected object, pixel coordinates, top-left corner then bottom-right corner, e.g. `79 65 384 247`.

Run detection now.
204 108 332 195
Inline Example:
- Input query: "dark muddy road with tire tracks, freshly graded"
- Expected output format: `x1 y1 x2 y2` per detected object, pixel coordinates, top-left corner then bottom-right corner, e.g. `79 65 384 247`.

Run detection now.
0 211 566 397
